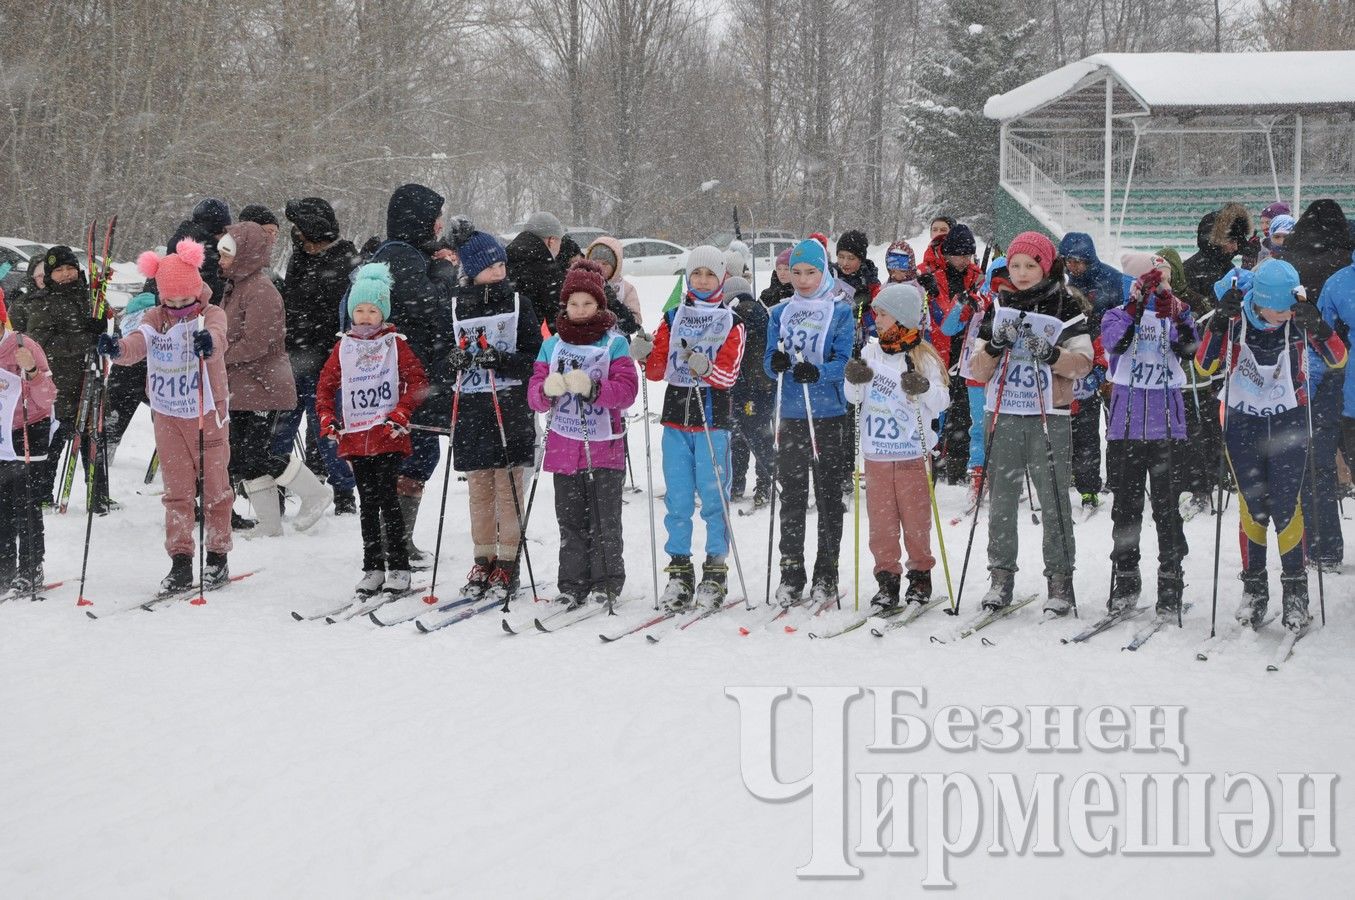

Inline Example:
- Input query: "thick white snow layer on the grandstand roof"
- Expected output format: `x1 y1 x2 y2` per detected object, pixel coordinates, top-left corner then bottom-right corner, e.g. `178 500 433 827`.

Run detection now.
984 50 1355 122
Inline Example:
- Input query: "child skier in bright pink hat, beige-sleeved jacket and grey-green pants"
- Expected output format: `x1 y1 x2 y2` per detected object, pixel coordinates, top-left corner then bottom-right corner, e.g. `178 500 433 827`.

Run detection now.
972 232 1092 615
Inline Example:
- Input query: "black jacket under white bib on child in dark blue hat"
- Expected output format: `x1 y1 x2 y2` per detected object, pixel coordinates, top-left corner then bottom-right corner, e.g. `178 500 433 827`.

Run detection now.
451 281 541 472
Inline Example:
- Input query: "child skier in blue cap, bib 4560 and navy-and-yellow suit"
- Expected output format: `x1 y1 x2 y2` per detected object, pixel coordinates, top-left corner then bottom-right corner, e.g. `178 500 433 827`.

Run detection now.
1195 259 1347 632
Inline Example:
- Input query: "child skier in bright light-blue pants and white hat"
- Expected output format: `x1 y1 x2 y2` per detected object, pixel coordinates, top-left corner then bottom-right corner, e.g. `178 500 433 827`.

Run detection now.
630 245 745 610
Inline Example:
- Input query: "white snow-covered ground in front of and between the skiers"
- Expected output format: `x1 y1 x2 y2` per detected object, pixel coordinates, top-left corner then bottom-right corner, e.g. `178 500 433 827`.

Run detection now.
0 273 1355 900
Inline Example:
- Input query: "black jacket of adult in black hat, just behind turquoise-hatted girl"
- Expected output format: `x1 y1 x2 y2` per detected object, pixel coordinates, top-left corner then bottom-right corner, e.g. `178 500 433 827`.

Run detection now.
282 240 357 378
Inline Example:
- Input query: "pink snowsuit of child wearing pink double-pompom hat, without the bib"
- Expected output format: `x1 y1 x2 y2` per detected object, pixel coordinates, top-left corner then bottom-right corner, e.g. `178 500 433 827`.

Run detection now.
114 306 234 556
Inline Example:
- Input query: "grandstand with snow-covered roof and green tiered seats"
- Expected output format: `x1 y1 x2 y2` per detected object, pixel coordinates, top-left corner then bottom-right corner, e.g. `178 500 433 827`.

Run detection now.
984 52 1355 260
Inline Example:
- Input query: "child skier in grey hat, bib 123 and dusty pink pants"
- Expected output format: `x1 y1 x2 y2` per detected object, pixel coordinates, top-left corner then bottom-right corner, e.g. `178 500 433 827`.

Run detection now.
846 283 950 609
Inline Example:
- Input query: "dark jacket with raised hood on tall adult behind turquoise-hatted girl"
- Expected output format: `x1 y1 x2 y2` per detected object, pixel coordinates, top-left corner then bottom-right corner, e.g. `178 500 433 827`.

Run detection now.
371 184 457 428
